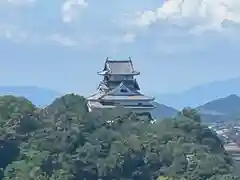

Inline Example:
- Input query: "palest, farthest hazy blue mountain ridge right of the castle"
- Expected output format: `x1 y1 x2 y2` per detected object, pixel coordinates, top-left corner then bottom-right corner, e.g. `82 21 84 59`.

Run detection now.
154 77 240 109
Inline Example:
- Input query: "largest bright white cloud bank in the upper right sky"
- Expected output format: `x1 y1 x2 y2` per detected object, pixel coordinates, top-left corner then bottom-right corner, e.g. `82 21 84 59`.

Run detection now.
126 0 240 31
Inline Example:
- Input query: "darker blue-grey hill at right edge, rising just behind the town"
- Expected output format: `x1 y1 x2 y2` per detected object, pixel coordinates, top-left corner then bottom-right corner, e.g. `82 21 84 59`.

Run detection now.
197 94 240 121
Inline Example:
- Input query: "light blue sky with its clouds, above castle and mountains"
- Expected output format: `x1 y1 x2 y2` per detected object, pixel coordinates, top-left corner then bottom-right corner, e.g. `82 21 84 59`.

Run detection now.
0 0 240 95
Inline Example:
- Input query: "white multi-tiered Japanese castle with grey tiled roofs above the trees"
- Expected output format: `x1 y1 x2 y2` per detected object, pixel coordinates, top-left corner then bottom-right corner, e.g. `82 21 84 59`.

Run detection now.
87 58 155 113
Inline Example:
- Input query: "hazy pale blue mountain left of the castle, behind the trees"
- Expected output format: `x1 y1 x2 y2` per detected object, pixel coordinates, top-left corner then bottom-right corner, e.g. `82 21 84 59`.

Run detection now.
0 86 61 107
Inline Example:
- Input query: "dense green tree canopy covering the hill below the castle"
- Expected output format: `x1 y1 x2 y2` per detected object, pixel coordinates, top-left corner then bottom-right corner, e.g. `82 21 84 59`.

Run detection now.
0 94 237 180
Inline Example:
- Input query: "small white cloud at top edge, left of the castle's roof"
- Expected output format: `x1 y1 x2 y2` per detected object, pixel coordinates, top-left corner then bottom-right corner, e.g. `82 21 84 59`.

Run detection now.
62 0 88 23
